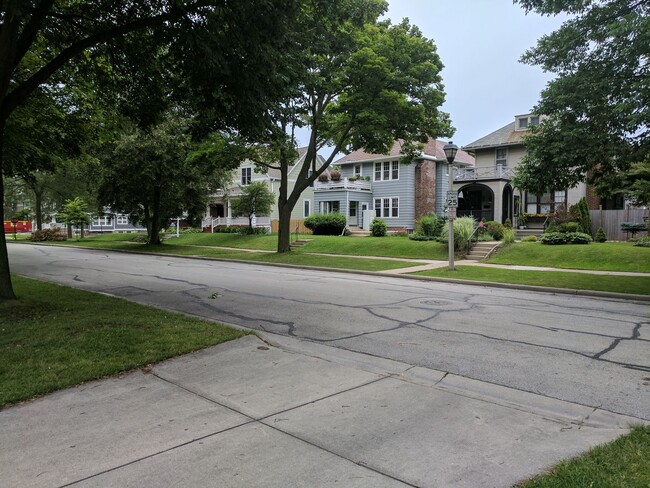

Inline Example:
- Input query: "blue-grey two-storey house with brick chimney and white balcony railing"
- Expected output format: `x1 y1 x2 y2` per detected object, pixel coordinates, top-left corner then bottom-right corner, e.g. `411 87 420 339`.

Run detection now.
314 139 474 232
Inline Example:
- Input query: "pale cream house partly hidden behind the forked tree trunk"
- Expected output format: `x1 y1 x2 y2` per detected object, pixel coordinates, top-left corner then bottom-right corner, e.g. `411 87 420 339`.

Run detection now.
203 147 325 231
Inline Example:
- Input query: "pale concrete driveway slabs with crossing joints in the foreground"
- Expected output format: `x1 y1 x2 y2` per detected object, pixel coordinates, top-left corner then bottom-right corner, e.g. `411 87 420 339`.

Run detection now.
0 335 638 488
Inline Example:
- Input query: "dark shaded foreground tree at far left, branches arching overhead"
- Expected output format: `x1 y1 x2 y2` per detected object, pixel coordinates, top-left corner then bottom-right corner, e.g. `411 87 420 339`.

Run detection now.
0 0 298 299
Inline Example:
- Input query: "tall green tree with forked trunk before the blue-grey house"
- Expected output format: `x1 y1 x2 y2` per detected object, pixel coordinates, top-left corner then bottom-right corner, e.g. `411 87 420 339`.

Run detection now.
247 0 453 252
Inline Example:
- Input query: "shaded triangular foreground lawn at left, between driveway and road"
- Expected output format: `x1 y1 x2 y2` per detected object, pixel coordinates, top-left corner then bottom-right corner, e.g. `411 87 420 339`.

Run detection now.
0 275 246 406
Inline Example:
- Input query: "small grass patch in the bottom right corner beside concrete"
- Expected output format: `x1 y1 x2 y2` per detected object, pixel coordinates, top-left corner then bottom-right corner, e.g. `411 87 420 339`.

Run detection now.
516 426 650 488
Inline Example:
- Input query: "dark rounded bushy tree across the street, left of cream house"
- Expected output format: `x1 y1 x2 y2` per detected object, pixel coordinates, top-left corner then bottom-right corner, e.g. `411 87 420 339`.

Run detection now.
99 113 243 244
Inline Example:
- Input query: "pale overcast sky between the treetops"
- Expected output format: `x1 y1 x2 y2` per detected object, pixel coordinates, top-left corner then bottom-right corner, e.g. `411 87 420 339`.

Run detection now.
386 0 566 146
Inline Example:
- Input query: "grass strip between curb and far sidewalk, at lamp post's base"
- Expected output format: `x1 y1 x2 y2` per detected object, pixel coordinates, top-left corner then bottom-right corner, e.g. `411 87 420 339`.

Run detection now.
414 266 650 295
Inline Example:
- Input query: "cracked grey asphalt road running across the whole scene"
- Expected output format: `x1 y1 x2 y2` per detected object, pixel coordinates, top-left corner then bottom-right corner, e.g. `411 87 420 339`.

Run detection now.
9 244 650 420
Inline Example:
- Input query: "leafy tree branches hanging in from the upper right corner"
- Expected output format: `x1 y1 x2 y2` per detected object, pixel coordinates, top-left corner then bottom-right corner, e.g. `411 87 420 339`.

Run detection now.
515 0 650 193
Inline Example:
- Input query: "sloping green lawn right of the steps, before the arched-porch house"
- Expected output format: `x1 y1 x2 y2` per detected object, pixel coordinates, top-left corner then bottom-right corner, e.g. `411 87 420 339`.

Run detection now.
487 242 650 273
